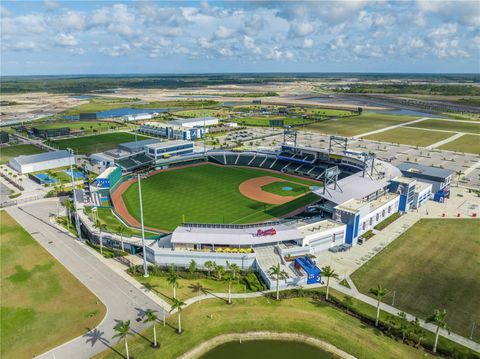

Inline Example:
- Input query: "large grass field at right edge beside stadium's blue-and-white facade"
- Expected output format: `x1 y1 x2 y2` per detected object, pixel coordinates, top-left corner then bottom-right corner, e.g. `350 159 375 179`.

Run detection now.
352 219 480 341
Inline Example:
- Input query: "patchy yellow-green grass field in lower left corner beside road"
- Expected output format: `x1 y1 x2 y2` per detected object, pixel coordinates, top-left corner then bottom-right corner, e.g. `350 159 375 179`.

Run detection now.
0 211 106 359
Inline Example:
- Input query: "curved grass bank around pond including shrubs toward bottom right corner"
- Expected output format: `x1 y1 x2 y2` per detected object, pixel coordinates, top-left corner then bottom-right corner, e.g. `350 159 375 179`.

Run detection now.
95 289 475 359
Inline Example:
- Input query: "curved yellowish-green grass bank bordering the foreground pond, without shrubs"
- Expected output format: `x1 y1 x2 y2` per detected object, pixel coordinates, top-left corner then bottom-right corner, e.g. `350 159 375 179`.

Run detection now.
94 291 430 359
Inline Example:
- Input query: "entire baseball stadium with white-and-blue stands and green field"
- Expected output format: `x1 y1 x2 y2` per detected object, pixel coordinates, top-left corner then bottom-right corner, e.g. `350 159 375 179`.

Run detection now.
76 136 454 286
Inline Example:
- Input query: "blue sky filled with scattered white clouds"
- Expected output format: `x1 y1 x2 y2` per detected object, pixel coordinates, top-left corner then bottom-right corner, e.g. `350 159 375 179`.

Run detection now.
0 0 480 76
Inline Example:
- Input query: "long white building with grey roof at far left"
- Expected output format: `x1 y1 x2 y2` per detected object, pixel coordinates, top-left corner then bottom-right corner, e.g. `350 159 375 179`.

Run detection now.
8 150 70 174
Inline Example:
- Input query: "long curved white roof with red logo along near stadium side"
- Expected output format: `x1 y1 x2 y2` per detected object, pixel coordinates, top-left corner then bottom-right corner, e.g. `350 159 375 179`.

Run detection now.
172 224 303 246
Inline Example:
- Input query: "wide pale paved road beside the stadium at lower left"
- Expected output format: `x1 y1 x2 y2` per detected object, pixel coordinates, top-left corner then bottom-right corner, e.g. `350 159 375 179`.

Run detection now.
7 200 167 359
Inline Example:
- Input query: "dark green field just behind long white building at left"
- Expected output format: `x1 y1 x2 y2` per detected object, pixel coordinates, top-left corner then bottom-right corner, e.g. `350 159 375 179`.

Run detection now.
49 132 149 155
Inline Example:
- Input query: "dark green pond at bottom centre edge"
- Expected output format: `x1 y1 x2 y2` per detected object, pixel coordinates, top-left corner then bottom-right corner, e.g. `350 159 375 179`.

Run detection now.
201 340 336 359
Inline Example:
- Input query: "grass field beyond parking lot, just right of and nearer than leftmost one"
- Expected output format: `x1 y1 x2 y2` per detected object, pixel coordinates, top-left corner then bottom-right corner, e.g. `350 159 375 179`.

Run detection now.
364 127 453 147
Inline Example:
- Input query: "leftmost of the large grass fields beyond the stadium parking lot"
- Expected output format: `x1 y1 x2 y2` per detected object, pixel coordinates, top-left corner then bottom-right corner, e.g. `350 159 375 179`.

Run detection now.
303 113 416 136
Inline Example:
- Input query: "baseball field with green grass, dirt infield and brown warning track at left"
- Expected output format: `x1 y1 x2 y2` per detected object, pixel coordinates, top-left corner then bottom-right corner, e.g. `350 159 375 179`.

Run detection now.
112 164 319 231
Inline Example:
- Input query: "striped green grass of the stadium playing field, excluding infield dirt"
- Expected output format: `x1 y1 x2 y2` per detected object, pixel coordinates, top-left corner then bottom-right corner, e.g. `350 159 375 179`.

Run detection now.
123 164 318 230
